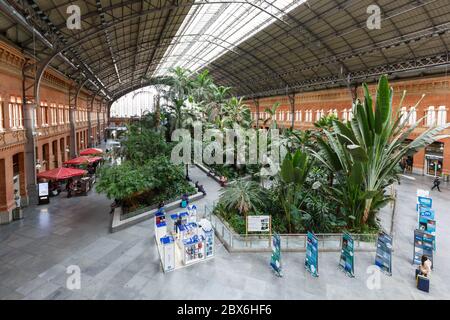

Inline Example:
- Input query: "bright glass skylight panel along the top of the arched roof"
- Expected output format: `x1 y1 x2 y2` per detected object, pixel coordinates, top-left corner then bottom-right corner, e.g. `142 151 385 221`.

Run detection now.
154 0 306 76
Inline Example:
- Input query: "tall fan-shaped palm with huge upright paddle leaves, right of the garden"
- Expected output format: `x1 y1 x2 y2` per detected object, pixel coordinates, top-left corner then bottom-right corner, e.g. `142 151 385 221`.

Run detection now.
312 76 450 226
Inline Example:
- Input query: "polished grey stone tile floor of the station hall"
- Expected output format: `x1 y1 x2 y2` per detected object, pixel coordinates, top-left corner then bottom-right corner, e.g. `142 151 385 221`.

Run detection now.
0 168 450 299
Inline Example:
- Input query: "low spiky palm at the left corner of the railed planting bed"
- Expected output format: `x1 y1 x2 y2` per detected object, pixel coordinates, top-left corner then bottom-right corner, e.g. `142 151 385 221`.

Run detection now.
219 180 266 216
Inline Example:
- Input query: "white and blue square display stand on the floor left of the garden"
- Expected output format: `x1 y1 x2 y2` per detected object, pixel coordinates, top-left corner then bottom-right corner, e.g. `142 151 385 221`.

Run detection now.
155 206 215 272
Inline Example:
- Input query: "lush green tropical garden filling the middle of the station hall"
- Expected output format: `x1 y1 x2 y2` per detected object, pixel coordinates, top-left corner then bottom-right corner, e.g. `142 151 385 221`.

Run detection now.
97 68 446 234
